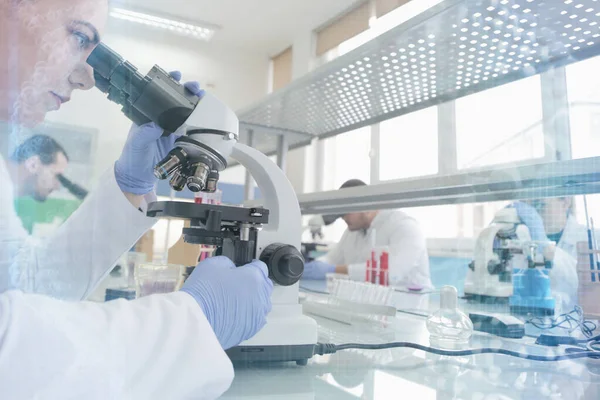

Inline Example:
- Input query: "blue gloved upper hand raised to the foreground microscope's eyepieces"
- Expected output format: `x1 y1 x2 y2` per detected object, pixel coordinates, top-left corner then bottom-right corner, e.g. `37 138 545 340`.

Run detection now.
115 71 204 195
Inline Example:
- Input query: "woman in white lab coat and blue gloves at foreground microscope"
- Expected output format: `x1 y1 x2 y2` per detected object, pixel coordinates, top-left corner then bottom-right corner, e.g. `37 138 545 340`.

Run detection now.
0 0 272 399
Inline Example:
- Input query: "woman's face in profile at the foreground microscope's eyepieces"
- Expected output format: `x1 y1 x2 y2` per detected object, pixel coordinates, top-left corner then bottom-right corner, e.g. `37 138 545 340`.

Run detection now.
0 0 108 126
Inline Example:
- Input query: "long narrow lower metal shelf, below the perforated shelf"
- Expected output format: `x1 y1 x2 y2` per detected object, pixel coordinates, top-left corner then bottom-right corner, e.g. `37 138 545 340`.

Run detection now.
298 157 600 214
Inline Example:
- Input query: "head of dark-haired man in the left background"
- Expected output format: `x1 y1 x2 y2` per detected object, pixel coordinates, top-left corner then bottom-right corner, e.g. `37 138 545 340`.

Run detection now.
6 135 69 203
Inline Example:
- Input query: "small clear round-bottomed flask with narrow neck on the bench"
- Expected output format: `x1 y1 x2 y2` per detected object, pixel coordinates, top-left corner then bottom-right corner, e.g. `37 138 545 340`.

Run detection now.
426 286 473 349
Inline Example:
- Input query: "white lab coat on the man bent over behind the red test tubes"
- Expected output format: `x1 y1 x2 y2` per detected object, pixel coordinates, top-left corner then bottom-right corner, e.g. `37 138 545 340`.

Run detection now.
326 210 433 288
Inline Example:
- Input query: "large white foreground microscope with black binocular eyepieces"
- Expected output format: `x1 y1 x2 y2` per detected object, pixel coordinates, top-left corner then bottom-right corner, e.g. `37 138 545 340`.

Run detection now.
87 43 317 365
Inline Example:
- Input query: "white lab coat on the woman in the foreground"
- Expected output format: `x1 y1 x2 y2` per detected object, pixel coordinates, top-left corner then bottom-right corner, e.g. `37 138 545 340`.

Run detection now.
0 158 233 400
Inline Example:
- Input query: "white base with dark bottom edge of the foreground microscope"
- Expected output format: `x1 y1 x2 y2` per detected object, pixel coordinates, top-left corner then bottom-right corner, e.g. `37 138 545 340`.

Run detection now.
227 304 318 365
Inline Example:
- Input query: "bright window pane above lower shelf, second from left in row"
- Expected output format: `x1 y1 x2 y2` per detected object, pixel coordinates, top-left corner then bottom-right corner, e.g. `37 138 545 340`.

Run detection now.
379 107 438 181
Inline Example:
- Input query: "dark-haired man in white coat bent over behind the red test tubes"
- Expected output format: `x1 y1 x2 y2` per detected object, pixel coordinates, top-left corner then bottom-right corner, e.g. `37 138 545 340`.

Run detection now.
303 179 432 289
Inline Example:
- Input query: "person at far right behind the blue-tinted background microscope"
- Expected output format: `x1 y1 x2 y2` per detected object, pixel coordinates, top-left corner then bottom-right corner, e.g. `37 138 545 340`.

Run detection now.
512 197 588 312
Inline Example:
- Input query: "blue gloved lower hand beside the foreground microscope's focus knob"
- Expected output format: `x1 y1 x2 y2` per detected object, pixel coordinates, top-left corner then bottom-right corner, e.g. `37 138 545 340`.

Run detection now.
181 257 273 350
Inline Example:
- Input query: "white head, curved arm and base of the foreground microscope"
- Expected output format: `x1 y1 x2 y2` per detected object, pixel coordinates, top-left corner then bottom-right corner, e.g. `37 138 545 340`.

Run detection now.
157 93 317 364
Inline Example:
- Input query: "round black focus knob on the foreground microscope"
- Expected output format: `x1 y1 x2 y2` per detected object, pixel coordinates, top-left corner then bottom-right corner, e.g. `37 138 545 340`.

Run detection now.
260 243 304 286
